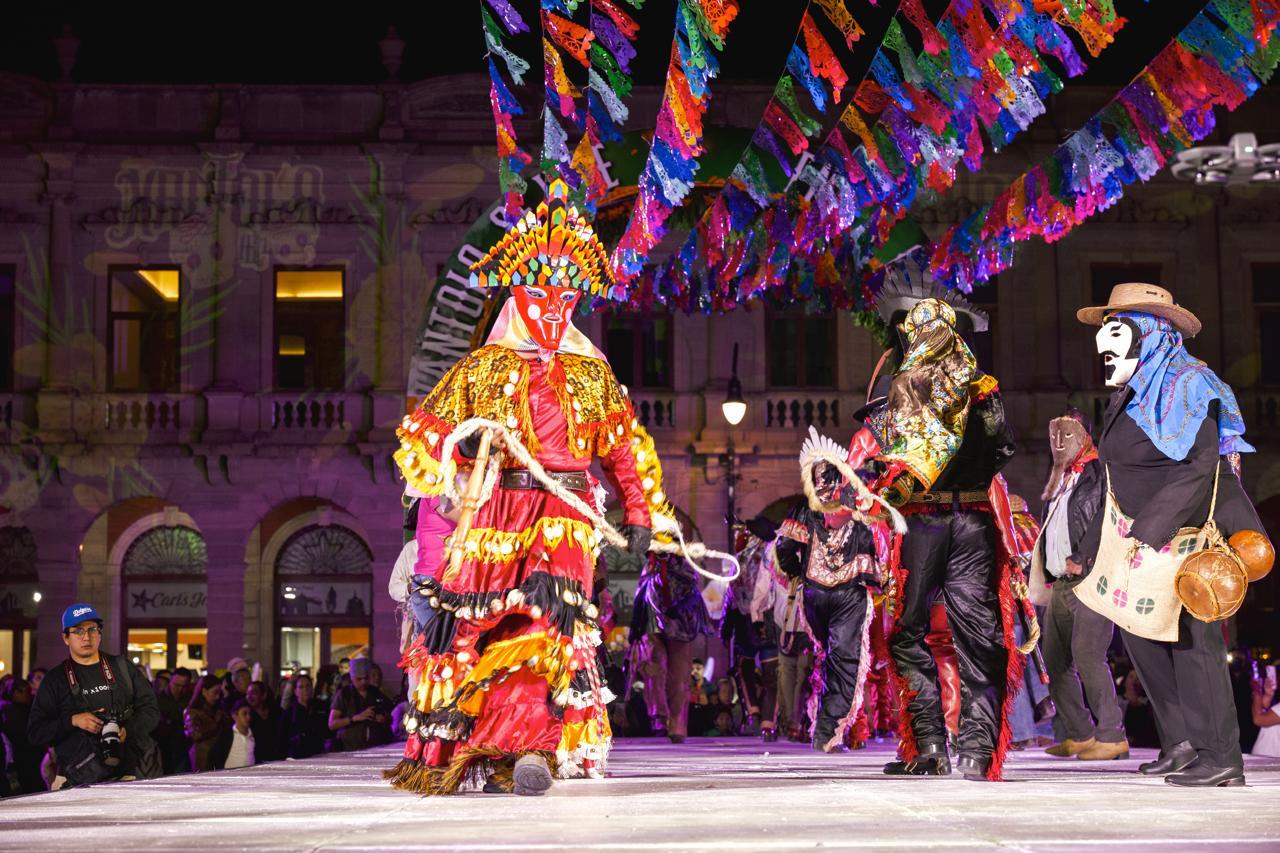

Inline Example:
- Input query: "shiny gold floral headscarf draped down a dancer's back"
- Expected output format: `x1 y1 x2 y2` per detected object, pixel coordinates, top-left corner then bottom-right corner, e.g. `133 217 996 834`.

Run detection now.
877 298 978 489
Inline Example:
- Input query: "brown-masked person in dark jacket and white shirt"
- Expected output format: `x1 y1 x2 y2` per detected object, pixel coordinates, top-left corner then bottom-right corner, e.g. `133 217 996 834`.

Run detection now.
1029 409 1129 761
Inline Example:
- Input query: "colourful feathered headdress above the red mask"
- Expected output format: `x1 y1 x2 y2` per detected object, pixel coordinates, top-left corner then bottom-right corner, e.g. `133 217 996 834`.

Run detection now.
471 179 626 300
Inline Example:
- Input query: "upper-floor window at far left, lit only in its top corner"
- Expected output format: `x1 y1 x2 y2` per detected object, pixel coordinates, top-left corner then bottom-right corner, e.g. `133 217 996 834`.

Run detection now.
108 268 182 392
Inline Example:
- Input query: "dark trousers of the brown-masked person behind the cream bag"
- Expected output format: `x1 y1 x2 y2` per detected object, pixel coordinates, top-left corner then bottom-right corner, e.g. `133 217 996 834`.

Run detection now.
1041 579 1125 743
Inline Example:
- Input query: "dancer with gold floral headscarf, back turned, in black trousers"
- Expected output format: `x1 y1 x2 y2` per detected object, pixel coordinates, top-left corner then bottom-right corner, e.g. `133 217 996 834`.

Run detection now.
854 282 1029 780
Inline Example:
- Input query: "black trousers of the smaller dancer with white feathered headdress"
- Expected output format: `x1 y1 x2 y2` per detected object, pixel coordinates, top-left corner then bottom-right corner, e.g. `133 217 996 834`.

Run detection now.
804 581 867 744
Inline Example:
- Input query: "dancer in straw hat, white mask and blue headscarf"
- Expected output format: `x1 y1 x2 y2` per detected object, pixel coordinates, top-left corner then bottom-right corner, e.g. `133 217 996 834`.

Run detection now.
1066 283 1263 786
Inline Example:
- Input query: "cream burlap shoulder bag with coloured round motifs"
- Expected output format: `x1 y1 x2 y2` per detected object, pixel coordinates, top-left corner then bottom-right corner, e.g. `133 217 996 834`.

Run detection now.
1074 469 1217 643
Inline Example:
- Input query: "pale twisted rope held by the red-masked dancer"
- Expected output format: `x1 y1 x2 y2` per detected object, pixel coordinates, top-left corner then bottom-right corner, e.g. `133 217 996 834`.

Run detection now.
440 418 742 581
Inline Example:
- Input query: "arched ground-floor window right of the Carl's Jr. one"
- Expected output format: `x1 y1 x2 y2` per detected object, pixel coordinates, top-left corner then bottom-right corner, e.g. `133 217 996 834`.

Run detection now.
275 517 374 675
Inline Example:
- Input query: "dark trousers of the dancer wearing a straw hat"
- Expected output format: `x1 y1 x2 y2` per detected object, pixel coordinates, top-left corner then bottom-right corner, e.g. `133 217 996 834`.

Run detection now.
1120 611 1244 767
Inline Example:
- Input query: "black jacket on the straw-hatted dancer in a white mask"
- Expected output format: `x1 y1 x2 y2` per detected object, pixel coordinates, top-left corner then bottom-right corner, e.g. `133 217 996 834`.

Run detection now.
1080 388 1265 566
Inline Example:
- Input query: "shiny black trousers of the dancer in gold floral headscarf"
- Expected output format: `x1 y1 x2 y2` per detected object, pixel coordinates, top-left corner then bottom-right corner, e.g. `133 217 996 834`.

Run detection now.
890 510 1009 758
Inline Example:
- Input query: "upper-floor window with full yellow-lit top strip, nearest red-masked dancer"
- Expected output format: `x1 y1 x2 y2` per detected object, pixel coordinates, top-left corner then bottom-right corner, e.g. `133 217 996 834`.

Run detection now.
275 269 347 391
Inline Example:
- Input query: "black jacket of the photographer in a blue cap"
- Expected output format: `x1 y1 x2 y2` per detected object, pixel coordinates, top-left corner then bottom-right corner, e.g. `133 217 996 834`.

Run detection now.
27 653 160 775
